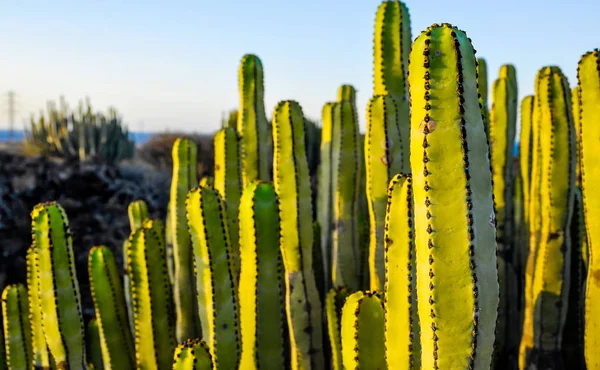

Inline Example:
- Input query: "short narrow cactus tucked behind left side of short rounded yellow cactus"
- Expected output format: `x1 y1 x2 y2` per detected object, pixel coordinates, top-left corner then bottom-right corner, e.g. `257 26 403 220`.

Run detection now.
325 287 351 370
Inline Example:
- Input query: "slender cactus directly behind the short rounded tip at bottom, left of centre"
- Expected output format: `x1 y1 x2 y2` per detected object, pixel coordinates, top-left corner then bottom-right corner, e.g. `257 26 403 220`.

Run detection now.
169 138 200 342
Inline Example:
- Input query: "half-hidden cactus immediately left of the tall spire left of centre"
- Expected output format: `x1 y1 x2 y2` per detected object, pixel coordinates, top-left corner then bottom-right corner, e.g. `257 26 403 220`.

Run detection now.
213 128 243 276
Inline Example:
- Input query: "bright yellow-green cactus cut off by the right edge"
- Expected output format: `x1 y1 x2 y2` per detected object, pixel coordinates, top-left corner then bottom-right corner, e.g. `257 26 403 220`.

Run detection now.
577 49 600 369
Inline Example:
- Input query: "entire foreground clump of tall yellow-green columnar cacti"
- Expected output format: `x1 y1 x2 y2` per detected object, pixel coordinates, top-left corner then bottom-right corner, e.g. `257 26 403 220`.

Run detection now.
0 1 600 370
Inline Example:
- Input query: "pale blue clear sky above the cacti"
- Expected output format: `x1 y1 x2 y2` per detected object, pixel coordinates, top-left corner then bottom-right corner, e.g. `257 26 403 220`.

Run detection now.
0 0 600 132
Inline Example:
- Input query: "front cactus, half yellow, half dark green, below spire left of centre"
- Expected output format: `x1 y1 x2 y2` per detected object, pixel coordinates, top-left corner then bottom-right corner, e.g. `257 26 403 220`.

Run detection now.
239 182 289 369
